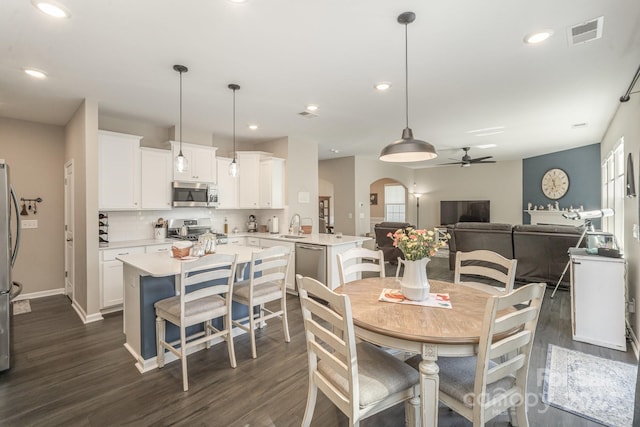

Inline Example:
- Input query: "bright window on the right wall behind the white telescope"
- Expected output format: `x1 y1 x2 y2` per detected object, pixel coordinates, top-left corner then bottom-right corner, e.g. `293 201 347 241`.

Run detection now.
602 137 625 250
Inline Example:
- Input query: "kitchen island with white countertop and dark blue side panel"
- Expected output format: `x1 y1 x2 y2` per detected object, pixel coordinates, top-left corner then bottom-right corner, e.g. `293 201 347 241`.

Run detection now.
117 245 260 372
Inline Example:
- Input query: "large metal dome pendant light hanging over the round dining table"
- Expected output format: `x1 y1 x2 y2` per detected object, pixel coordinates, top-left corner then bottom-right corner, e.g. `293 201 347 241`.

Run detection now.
380 12 438 163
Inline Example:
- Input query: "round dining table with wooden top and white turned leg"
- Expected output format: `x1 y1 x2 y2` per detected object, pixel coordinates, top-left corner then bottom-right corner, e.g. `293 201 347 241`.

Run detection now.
335 277 500 426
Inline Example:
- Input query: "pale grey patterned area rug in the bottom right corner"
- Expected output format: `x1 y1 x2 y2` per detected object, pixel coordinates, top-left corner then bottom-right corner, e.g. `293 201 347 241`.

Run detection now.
542 344 637 427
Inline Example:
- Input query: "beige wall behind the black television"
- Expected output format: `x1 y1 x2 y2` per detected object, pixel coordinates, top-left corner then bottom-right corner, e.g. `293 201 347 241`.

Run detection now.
409 160 522 228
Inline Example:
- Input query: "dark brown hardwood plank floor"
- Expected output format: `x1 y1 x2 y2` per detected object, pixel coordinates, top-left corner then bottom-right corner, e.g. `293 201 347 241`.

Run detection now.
0 258 636 427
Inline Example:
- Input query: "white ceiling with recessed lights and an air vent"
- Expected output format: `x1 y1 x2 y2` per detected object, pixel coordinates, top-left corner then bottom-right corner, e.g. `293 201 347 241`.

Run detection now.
0 0 640 167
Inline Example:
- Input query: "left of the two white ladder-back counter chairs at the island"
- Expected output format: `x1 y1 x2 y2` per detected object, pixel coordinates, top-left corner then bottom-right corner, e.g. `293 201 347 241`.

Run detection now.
154 254 237 391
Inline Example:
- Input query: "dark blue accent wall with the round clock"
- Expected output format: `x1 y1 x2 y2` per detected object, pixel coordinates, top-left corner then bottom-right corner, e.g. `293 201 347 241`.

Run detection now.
522 144 601 228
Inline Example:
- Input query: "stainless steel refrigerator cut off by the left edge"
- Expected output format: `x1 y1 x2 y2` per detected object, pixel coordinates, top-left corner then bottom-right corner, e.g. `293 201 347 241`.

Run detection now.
0 159 20 371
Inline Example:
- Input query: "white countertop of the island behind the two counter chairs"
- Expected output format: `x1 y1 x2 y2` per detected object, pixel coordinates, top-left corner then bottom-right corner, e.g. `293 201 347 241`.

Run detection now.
116 245 260 277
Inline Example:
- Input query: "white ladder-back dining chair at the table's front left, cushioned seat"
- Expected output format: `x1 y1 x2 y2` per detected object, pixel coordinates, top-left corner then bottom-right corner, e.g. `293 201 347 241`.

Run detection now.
297 276 420 427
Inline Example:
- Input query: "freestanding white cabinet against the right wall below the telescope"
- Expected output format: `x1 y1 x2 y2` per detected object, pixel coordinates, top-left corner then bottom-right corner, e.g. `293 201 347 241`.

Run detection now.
569 248 627 351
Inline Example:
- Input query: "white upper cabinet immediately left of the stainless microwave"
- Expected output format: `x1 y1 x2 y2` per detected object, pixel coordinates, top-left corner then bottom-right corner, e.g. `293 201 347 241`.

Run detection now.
140 147 173 210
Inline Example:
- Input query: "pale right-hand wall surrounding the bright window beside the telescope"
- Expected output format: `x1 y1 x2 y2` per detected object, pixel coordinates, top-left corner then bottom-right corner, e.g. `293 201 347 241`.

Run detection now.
600 84 640 352
